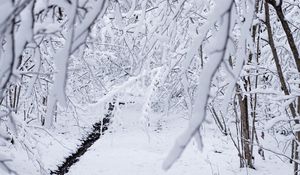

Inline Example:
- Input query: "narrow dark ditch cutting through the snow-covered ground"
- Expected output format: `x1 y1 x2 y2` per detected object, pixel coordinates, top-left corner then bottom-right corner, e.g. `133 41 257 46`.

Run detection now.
50 101 115 175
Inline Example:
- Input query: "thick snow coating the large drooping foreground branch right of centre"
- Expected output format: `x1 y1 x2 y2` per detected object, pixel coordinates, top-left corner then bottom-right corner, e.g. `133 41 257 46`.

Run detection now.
163 1 236 170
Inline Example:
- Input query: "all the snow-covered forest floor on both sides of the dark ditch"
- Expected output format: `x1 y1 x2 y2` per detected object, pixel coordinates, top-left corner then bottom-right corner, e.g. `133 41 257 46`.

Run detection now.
0 96 293 175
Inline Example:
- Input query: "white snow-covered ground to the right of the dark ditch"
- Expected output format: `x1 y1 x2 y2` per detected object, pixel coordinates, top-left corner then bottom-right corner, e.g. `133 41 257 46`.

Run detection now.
68 104 291 175
